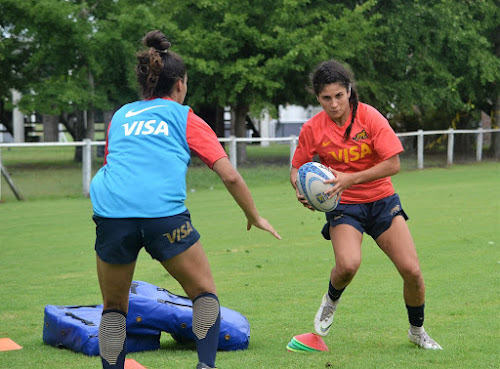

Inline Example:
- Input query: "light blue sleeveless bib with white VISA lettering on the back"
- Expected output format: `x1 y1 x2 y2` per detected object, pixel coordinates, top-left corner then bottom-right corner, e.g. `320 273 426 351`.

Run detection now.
90 99 191 218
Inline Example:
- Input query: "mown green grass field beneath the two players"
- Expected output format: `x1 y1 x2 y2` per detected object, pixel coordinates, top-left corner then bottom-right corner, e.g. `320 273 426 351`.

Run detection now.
0 155 500 369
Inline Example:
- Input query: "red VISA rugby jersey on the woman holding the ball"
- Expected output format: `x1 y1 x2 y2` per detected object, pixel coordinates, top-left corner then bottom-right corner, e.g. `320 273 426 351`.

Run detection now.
292 102 403 204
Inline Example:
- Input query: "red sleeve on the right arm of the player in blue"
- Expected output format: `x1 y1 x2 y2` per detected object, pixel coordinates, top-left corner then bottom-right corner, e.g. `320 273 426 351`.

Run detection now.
186 110 227 169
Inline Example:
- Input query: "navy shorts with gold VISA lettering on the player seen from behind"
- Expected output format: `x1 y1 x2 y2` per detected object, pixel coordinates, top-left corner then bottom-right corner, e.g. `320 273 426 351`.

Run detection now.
92 210 200 264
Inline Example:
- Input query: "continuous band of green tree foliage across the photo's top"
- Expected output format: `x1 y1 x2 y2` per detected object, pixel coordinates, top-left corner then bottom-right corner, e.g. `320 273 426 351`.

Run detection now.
0 0 500 134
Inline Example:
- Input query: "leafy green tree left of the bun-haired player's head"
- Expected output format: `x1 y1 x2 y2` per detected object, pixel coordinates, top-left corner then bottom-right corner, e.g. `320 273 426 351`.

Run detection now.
0 0 165 160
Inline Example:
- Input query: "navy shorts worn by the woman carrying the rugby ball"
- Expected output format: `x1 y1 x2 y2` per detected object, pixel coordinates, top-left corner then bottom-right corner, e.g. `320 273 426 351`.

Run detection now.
321 194 408 240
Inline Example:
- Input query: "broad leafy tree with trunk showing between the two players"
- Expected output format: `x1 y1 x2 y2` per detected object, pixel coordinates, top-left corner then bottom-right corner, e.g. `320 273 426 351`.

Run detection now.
160 0 375 162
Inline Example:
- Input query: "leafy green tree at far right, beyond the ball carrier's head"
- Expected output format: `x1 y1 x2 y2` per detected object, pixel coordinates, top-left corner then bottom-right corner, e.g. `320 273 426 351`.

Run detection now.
359 0 500 135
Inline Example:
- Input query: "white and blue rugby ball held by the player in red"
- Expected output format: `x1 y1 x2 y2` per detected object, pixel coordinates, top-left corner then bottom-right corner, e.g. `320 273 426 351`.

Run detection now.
296 162 340 213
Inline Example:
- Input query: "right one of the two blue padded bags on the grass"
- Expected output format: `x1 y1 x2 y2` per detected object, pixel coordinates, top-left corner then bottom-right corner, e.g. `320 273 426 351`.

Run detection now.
127 281 250 351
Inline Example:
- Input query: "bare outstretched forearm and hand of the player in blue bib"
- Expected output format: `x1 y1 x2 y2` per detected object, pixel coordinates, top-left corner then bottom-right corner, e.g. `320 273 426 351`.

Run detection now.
212 157 281 240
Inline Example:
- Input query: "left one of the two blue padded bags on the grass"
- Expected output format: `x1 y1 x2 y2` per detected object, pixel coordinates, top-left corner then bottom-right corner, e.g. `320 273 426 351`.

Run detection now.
43 305 161 356
